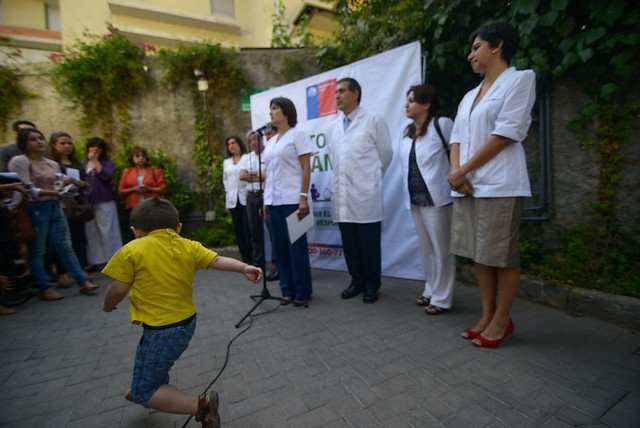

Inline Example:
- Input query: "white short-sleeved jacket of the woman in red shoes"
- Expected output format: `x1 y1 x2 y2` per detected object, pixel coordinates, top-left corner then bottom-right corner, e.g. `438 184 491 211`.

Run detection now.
450 67 536 198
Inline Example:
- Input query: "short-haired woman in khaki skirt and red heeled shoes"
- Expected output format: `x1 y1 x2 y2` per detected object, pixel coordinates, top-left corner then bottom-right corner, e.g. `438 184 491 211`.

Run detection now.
448 22 536 348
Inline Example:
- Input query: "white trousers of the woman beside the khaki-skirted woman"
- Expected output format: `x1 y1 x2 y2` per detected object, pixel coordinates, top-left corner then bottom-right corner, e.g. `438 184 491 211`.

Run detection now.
411 204 456 309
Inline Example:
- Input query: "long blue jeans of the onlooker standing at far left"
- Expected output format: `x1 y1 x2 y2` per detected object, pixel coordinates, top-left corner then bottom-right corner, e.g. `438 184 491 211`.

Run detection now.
27 201 87 291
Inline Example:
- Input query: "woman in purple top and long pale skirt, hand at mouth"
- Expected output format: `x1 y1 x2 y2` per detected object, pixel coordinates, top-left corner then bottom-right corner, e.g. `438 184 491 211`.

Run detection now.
81 137 122 266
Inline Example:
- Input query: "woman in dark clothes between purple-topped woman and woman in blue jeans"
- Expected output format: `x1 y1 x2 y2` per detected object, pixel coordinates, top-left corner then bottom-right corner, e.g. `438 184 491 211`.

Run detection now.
49 131 93 288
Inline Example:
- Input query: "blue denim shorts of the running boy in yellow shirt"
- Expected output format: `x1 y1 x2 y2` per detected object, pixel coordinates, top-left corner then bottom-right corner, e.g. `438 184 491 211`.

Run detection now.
131 316 197 404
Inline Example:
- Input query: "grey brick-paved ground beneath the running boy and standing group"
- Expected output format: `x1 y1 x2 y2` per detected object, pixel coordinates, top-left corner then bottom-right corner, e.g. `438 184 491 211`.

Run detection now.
0 270 640 428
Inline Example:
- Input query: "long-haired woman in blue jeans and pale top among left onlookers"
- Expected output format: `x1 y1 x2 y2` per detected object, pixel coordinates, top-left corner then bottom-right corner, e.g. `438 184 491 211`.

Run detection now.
9 128 98 300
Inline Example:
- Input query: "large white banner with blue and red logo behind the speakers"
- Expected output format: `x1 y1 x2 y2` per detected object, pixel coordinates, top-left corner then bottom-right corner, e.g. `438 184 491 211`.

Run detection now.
251 42 424 279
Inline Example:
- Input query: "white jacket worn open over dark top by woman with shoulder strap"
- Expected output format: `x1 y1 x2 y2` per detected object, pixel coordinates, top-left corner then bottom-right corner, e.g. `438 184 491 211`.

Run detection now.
398 117 453 209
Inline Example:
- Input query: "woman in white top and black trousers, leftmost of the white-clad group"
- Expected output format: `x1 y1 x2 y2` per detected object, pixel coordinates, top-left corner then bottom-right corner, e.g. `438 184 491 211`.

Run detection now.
222 136 251 264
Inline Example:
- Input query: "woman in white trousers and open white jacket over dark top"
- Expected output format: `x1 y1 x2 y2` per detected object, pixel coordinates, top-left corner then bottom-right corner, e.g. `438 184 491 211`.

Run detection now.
399 84 456 315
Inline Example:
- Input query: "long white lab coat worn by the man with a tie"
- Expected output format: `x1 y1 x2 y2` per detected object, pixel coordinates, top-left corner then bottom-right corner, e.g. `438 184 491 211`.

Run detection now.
326 107 393 223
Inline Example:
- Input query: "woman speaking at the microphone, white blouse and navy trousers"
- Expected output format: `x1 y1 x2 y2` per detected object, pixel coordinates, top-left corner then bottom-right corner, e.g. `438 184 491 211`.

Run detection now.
264 98 313 307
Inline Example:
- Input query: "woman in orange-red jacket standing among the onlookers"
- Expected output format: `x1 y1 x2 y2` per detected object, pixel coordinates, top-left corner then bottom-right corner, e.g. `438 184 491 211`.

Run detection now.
118 146 167 234
